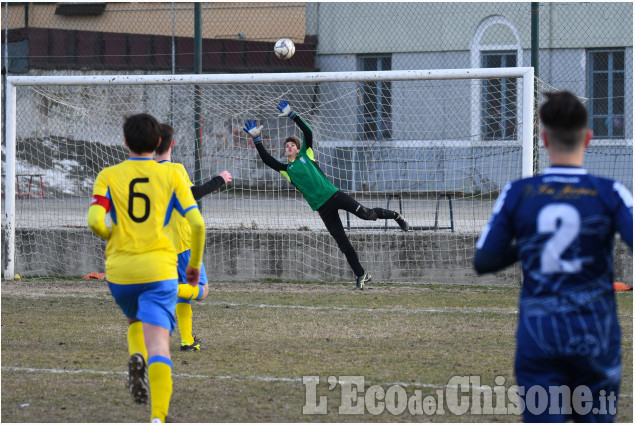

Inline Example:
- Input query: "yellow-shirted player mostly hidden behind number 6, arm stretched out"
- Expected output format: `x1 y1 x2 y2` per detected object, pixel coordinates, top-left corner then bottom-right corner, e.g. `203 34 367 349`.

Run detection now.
155 123 232 351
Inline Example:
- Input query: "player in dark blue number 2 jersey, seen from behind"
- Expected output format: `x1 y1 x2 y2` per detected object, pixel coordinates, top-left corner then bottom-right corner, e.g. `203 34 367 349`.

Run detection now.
474 92 633 422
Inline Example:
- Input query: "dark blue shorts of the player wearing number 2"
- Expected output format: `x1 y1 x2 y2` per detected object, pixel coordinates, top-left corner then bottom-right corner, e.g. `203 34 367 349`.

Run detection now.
514 306 622 422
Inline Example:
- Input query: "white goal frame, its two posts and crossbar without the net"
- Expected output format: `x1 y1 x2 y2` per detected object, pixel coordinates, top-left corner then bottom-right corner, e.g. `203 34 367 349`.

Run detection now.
3 67 535 280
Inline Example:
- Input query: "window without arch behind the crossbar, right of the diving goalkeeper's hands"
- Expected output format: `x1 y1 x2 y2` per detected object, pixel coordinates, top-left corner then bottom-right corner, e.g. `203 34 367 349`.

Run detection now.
358 55 392 140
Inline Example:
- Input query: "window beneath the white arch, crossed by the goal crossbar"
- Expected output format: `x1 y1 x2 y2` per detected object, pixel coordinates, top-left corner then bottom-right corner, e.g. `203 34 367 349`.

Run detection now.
481 51 517 140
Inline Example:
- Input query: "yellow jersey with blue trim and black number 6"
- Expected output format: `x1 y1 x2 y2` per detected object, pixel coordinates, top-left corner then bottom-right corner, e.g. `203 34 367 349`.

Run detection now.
93 158 198 284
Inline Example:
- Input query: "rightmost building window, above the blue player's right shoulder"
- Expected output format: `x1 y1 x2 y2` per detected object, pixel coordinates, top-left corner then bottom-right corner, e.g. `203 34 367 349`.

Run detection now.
589 49 624 138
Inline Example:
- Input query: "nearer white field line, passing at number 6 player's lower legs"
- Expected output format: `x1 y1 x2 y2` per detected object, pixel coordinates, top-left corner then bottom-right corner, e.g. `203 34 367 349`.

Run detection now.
2 366 633 398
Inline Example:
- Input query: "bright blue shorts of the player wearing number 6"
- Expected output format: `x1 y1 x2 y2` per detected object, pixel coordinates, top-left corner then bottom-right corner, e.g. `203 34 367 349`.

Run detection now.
108 279 178 334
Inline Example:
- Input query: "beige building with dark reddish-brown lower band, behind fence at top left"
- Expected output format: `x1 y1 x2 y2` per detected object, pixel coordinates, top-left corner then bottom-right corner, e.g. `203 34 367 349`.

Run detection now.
2 2 315 74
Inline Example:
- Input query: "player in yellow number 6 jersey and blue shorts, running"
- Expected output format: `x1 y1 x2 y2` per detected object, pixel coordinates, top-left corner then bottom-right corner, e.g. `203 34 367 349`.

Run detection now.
88 114 205 422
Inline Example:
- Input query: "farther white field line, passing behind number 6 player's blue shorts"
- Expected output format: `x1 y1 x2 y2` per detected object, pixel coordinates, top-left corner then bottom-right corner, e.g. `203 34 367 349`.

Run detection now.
0 293 518 315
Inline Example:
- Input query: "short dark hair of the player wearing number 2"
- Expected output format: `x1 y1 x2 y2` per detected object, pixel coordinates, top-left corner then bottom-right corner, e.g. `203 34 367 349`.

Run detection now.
540 91 589 150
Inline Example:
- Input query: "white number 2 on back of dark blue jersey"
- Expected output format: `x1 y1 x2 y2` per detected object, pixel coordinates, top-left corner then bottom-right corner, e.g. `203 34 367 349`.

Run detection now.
537 203 582 274
